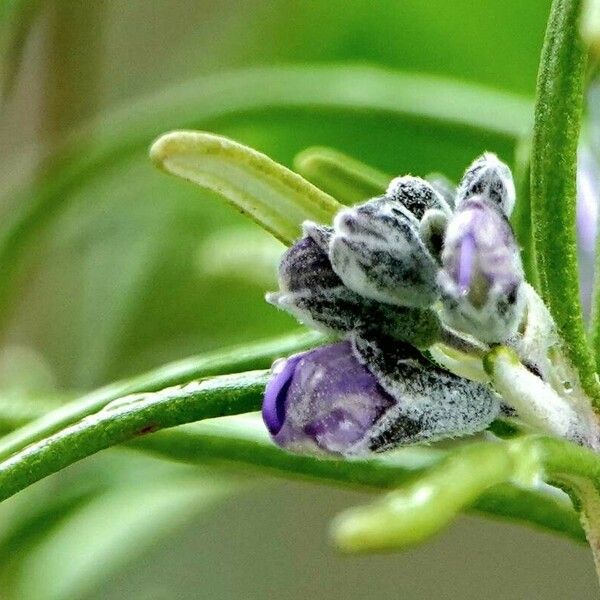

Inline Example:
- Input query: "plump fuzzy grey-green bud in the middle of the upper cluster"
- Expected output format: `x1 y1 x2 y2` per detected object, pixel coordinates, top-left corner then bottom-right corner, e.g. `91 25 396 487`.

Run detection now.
329 197 439 307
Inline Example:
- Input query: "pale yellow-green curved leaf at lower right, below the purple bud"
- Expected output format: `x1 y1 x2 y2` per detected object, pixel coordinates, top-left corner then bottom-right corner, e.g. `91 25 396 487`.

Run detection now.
334 436 600 560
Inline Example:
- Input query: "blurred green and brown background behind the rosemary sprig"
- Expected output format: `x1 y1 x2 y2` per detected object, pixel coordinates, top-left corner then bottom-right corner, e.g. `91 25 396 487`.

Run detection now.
0 0 597 600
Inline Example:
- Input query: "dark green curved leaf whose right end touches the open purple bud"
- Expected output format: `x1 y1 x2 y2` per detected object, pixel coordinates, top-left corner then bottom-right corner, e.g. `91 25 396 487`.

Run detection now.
0 371 269 501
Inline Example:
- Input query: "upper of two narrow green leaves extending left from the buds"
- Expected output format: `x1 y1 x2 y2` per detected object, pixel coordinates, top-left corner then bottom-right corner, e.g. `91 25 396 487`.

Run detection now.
0 331 326 460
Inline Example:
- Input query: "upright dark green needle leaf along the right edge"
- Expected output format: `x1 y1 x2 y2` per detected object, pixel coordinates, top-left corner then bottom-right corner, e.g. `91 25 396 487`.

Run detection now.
531 0 600 407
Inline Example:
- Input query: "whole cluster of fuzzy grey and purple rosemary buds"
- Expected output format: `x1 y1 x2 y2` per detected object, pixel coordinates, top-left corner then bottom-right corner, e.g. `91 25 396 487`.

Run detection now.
263 153 600 456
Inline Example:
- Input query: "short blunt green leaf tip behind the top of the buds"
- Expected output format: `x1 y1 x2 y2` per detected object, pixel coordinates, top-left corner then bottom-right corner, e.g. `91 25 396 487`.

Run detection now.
294 147 392 205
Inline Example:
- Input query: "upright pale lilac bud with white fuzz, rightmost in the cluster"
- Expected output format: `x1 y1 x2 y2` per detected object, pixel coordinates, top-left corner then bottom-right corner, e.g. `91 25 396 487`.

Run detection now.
438 196 525 343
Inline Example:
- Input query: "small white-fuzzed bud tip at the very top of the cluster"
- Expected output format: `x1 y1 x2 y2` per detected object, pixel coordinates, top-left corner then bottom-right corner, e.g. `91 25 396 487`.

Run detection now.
456 152 515 217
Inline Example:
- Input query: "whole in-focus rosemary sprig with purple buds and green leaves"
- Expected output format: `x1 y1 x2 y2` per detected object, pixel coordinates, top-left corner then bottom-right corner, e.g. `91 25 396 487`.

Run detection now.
0 0 600 592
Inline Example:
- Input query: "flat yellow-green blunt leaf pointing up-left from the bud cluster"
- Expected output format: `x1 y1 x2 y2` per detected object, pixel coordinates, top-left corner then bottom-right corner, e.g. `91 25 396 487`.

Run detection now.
150 131 342 245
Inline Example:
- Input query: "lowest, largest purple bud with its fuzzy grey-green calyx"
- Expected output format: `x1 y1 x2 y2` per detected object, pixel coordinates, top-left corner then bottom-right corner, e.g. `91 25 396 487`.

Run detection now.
263 336 500 456
